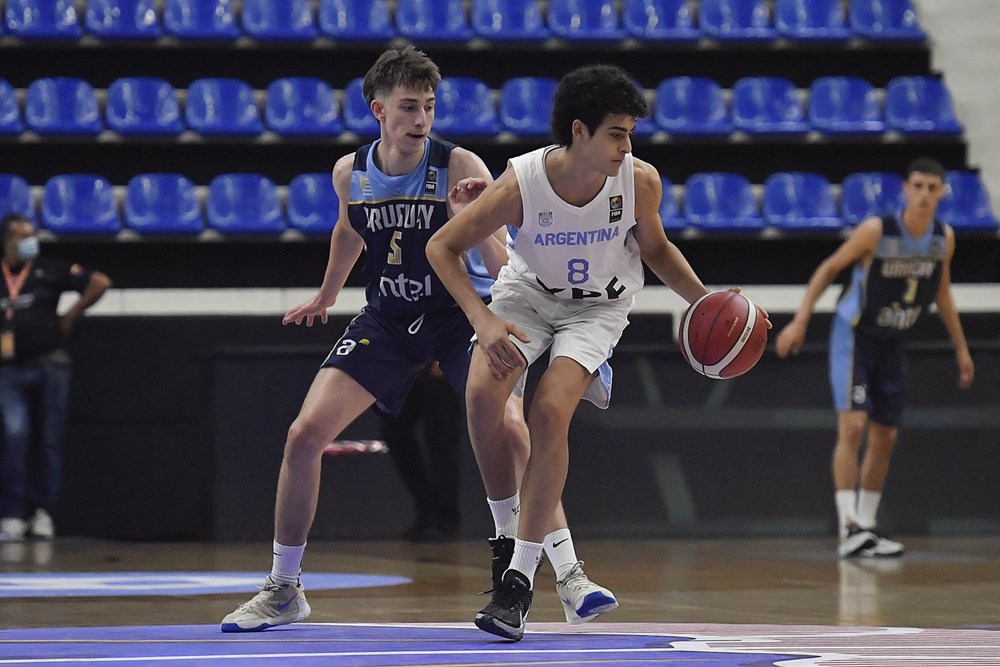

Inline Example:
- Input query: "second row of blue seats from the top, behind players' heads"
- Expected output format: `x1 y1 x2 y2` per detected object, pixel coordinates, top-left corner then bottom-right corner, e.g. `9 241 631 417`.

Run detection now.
0 76 963 137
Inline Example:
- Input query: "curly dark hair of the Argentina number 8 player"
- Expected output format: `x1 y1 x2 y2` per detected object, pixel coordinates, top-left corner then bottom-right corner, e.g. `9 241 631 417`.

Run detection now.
552 65 649 146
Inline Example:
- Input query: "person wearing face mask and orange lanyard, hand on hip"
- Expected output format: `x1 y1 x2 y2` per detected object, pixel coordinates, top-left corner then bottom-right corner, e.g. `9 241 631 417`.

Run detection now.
0 213 111 542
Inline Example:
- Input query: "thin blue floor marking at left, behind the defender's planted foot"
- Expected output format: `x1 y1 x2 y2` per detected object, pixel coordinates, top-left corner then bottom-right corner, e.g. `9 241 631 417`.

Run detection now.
0 572 411 598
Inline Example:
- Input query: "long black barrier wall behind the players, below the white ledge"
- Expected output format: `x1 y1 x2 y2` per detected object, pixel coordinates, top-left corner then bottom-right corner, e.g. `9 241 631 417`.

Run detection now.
57 314 1000 540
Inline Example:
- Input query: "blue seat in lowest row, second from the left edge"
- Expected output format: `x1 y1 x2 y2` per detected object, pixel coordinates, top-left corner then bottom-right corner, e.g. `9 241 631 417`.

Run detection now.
42 174 121 234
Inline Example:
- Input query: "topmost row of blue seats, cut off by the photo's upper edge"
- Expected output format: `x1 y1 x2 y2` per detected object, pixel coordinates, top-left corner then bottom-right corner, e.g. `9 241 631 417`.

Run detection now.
4 0 926 41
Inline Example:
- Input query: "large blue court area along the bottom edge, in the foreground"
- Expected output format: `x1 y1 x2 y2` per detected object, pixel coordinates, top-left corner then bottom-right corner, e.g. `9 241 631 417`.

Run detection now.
0 623 804 667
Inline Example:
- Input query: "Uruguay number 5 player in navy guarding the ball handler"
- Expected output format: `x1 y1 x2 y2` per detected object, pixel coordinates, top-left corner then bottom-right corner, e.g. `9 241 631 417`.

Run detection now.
221 46 603 632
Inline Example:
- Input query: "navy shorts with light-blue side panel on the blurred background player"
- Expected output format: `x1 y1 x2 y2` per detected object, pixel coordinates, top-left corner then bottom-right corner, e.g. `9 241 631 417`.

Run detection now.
830 317 906 426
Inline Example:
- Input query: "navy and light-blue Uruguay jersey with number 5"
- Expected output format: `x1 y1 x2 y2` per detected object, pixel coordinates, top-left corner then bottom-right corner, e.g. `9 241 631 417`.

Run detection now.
347 138 492 318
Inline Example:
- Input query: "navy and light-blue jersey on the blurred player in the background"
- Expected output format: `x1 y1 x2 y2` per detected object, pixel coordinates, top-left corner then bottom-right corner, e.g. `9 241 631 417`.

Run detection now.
837 216 947 339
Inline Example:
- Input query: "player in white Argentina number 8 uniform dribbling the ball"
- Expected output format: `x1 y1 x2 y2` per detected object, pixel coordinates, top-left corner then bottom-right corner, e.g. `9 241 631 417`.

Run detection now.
427 65 732 640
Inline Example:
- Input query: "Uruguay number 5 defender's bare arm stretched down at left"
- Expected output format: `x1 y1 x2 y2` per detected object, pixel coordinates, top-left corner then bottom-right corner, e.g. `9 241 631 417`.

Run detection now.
281 154 364 327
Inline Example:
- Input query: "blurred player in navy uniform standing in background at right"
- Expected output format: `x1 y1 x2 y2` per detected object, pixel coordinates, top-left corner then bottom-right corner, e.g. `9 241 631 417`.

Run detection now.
776 158 974 558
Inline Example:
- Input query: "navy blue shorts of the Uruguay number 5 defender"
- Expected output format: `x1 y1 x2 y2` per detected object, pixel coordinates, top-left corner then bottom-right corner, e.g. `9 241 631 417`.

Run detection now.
323 307 474 414
